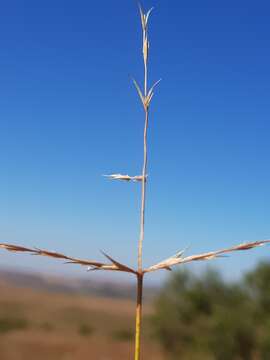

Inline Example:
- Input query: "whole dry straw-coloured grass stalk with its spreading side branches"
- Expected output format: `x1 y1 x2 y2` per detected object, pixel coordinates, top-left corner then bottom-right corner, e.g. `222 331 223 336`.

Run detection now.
0 6 270 360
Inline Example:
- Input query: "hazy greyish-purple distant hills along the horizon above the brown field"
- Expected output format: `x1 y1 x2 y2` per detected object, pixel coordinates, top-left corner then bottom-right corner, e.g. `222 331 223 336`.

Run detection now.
0 269 158 300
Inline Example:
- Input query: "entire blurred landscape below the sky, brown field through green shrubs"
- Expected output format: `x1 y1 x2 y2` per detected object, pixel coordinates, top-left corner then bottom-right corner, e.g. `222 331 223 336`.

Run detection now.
0 261 270 360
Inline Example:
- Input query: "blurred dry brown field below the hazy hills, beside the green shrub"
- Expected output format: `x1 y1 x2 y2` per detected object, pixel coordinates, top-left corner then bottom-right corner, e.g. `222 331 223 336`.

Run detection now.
0 283 163 360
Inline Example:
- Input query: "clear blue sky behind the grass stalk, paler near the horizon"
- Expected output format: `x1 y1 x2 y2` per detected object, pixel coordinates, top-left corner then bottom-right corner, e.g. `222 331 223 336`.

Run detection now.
0 0 270 277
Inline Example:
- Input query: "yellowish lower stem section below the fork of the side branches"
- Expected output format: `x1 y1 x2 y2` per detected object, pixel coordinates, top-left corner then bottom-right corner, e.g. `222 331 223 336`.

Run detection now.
135 274 143 360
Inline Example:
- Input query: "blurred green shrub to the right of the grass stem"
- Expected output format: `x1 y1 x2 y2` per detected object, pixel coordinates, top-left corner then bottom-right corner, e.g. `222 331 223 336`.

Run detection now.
152 264 270 360
